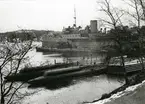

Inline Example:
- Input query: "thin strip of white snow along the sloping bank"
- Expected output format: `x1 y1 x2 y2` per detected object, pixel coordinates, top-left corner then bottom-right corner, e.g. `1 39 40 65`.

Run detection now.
88 81 145 104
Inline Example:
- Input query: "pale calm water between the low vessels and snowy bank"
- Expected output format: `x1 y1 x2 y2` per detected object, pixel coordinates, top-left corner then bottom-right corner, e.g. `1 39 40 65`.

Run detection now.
23 75 124 104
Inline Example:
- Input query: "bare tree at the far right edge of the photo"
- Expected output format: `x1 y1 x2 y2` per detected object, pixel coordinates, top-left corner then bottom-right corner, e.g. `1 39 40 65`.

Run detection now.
123 0 145 71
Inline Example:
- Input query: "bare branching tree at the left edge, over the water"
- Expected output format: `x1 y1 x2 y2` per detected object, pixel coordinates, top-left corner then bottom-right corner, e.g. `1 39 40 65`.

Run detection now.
0 32 32 104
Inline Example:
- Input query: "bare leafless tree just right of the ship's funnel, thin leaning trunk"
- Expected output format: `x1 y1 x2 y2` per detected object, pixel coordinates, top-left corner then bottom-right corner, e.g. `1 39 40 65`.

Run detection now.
98 0 131 83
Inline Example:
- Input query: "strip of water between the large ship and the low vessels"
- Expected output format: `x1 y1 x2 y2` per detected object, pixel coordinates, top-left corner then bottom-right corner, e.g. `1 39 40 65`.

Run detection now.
28 50 100 66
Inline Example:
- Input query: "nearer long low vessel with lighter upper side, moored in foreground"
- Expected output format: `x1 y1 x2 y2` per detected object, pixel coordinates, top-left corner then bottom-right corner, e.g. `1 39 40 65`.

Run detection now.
28 65 106 86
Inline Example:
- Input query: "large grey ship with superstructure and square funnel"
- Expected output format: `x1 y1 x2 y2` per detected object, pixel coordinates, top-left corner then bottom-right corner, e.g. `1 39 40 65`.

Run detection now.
42 20 113 53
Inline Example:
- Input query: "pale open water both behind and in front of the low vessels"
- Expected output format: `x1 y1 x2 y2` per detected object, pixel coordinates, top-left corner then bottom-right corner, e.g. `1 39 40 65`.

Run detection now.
22 47 124 104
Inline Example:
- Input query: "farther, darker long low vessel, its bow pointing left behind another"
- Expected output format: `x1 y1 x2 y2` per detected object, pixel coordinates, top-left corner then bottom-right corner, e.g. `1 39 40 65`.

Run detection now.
5 63 74 82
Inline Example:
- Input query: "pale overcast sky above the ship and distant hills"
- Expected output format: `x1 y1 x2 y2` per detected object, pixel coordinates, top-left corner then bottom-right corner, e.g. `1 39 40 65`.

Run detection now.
0 0 124 32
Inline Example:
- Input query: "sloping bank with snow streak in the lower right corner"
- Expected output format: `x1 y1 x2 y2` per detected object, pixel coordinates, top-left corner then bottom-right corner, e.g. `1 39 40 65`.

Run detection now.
87 75 145 104
